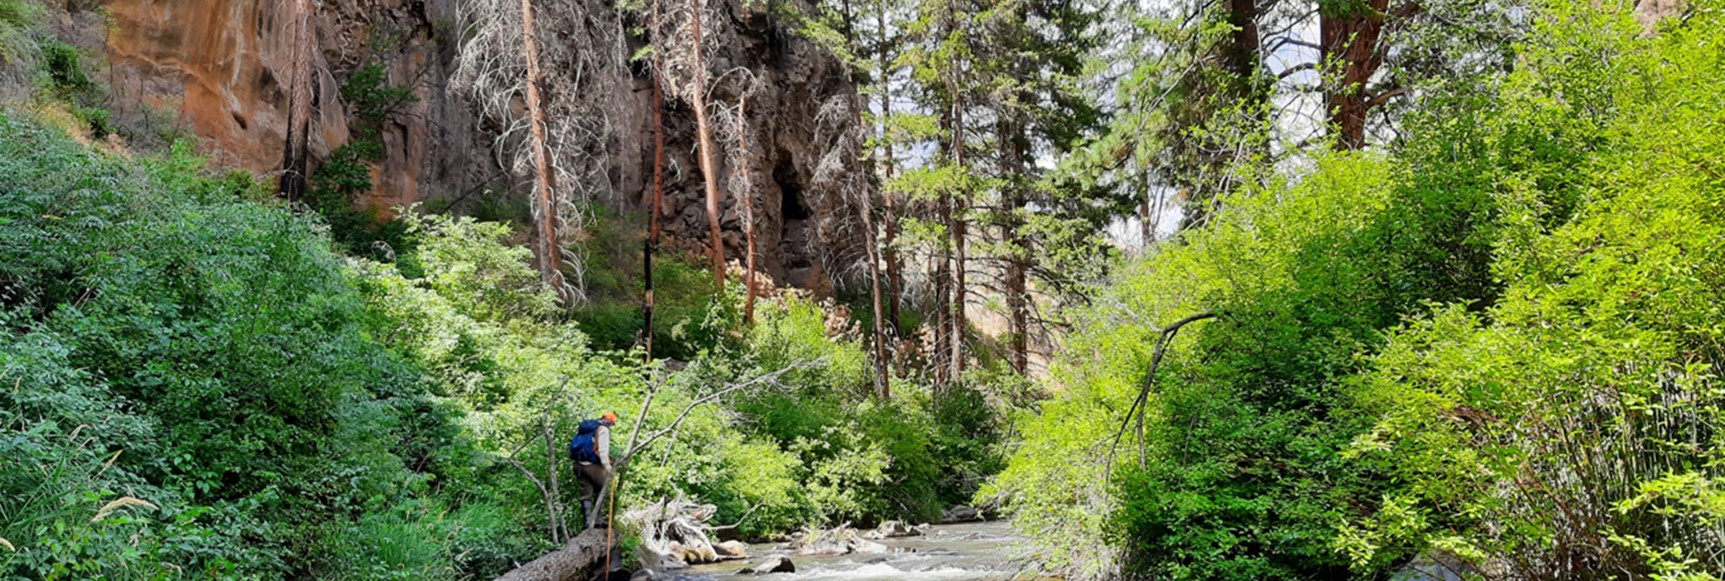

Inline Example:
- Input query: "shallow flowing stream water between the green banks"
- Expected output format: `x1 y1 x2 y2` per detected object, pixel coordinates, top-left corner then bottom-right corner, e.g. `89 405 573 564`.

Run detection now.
655 521 1049 581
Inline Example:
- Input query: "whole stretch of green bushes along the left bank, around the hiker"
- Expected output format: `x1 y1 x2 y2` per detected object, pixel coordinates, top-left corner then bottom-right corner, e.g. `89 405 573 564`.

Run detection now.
0 99 999 579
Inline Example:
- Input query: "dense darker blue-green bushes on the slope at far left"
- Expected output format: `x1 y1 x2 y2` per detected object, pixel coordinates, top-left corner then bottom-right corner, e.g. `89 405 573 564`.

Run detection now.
0 116 465 578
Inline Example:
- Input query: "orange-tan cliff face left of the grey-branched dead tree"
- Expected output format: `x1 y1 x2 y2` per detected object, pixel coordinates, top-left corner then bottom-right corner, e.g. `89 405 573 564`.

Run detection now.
105 0 486 210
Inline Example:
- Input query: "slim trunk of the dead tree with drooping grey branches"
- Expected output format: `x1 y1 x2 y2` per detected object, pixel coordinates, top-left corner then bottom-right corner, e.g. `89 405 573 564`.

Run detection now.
521 0 568 291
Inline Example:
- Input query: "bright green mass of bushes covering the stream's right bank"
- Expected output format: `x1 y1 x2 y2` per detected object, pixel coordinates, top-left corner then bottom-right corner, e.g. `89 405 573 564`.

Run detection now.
983 2 1725 579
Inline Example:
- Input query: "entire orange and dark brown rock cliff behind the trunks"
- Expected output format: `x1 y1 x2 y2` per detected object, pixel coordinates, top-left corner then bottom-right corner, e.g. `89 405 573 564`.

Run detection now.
83 0 861 290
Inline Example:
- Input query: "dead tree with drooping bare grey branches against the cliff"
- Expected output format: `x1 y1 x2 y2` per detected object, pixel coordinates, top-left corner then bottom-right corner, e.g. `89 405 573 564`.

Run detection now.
450 0 628 302
